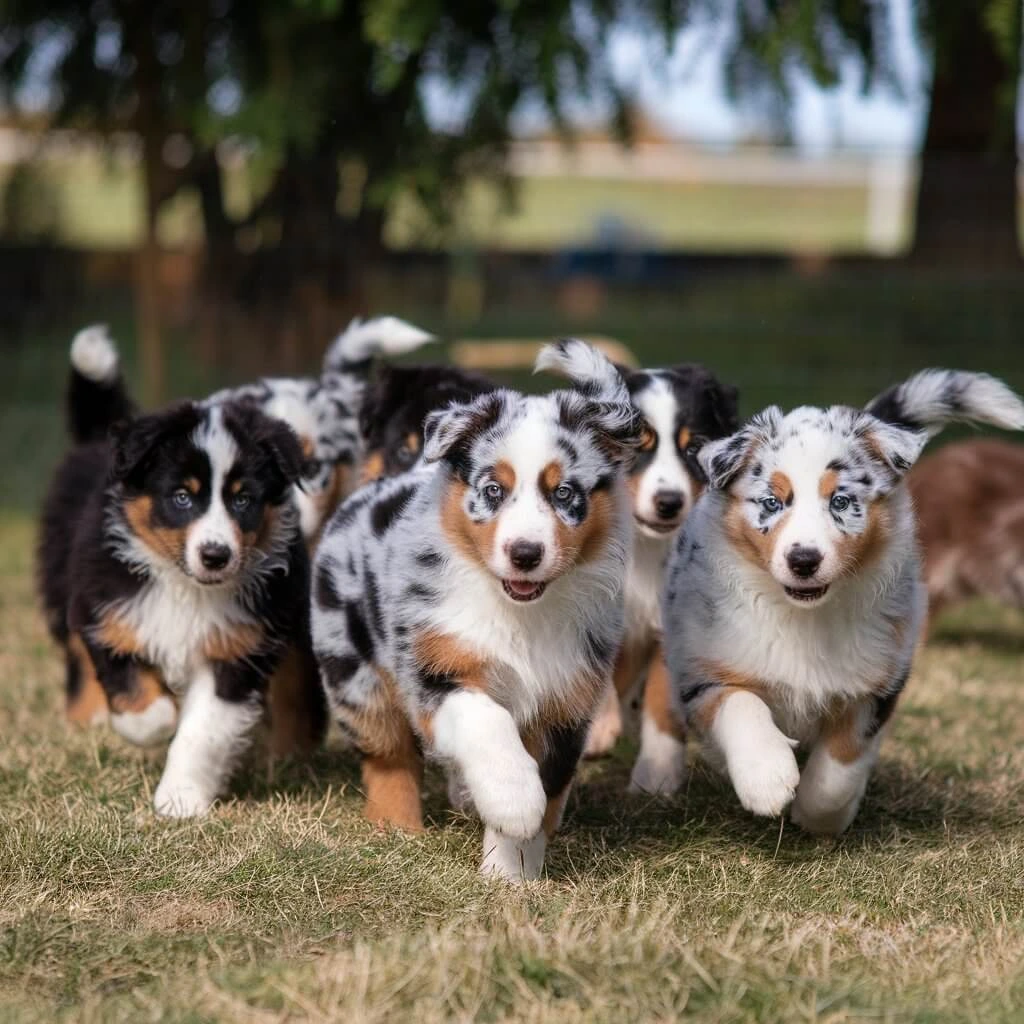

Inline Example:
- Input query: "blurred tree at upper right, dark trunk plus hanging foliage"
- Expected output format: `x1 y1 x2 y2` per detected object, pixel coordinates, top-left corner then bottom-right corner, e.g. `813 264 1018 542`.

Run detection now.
716 0 1022 266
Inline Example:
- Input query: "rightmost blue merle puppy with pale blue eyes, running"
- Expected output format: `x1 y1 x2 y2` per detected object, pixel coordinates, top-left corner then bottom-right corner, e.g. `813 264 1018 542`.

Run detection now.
664 370 1024 835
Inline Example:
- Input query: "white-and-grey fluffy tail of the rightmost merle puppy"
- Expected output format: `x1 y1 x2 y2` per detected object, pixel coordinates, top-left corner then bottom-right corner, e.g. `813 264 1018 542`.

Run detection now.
865 370 1024 437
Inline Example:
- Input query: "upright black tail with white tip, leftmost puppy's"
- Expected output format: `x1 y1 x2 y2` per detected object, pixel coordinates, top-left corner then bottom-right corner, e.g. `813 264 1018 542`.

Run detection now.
68 325 135 444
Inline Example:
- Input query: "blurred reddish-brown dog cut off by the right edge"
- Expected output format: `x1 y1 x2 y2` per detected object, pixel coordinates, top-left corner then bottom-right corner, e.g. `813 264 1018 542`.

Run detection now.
907 438 1024 623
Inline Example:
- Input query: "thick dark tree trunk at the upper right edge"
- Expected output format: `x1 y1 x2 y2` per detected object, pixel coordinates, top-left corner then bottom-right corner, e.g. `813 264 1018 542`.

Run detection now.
911 0 1021 267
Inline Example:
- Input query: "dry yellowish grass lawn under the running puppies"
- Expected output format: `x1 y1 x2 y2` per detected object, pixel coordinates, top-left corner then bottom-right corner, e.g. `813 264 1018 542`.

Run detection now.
0 519 1024 1024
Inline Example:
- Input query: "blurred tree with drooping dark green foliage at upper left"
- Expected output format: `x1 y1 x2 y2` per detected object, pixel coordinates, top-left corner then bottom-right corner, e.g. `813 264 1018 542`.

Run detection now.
0 0 689 392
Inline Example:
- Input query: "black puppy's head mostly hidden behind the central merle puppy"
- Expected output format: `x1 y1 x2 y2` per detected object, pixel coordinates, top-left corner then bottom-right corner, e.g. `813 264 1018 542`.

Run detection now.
359 364 498 483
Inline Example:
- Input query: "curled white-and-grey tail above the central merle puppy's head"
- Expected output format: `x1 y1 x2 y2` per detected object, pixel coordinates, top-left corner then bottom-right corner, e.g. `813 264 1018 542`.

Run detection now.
534 338 640 447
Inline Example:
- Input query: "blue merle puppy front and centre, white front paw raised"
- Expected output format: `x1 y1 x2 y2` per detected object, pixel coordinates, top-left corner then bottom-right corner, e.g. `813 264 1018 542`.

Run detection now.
312 340 640 879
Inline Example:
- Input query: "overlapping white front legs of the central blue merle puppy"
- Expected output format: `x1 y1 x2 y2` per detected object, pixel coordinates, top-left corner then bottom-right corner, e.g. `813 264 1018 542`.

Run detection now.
432 689 548 881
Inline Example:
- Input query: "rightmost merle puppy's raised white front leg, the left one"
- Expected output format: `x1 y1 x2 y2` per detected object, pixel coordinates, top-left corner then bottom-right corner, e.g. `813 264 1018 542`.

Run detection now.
700 685 800 817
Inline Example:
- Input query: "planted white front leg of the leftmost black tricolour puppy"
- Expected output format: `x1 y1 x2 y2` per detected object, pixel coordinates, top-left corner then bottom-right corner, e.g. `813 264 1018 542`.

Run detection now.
153 663 265 818
